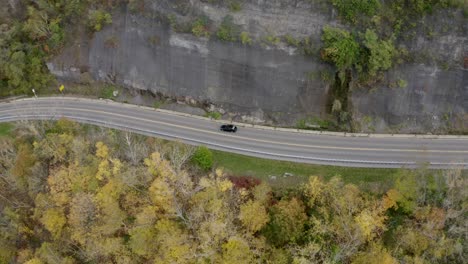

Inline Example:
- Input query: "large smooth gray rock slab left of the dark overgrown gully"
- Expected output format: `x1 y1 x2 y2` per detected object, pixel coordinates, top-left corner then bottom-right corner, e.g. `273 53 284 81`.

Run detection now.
49 6 327 124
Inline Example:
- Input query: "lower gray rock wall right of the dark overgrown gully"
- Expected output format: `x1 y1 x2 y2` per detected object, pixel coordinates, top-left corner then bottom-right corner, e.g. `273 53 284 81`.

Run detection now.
351 65 468 133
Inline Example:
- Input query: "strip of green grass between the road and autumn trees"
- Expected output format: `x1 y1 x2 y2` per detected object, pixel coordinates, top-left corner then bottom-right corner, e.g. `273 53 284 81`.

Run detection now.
213 150 399 189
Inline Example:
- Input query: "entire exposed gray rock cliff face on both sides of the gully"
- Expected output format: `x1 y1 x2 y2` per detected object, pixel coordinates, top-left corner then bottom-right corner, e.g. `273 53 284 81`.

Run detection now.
48 0 468 133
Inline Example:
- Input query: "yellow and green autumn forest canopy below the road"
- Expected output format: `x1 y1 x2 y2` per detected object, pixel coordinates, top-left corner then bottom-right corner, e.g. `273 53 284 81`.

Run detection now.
0 119 468 263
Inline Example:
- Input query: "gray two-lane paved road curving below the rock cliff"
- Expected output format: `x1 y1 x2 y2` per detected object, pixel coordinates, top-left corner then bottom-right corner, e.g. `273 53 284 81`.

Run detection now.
0 97 468 168
